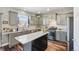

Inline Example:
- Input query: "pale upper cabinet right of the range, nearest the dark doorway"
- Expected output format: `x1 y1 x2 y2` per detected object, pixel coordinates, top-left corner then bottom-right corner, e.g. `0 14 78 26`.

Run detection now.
57 15 67 26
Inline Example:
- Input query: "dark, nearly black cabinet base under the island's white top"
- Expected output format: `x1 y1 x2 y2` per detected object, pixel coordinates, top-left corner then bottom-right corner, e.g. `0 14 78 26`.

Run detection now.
32 34 48 51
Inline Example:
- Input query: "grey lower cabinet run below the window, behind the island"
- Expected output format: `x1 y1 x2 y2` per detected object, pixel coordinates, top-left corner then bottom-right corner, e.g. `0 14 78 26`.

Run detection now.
9 31 30 48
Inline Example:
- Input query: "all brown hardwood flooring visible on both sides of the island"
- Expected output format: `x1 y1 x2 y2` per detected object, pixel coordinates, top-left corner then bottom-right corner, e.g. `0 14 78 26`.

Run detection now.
0 41 67 51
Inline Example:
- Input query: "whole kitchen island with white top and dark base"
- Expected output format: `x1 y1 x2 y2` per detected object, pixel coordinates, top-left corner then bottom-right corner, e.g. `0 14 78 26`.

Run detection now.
15 31 48 51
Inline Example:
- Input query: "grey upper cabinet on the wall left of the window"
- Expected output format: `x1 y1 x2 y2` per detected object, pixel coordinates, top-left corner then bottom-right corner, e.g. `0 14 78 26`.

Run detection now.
9 11 19 26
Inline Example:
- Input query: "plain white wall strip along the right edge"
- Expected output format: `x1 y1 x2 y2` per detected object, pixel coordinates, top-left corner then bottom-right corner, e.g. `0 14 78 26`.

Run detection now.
74 7 79 51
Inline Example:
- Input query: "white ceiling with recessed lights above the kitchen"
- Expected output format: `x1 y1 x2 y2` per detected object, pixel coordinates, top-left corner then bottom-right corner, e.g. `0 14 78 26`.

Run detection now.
17 7 73 14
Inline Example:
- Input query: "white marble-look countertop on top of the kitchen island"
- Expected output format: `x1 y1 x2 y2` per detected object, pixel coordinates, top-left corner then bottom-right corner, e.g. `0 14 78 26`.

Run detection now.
15 31 48 44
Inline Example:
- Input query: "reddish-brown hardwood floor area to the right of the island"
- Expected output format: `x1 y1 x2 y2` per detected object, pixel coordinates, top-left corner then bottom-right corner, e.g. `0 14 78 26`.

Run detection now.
45 41 67 51
